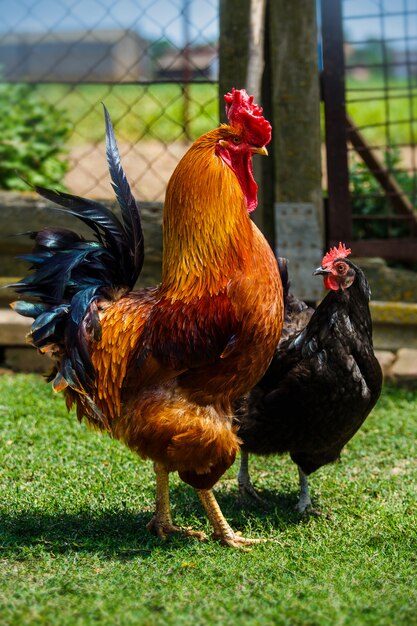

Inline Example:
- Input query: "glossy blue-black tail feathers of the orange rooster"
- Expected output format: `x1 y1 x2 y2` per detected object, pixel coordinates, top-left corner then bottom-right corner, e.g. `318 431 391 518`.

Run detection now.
11 107 144 403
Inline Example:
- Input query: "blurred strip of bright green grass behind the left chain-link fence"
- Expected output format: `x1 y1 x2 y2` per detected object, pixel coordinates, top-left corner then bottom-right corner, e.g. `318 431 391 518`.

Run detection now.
35 84 219 145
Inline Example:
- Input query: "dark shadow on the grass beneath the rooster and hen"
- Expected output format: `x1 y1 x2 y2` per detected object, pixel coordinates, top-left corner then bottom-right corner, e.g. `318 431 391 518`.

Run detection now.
0 485 300 559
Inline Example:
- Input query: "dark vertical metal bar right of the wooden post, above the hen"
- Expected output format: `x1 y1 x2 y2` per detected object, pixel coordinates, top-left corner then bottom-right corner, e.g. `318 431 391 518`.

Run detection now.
321 0 352 241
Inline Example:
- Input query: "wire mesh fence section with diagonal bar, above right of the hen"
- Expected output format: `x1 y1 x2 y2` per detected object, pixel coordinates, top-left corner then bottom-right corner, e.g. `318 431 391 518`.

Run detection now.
342 0 417 239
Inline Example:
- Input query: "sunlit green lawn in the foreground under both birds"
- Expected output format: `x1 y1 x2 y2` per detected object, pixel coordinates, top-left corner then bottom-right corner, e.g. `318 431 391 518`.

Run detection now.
0 375 417 626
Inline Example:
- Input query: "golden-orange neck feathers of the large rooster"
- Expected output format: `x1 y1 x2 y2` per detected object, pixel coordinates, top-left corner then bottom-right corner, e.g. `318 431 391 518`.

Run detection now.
161 127 253 299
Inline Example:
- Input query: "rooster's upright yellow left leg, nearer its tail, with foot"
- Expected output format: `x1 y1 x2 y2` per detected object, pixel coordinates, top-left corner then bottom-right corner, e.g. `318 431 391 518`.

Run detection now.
146 463 206 541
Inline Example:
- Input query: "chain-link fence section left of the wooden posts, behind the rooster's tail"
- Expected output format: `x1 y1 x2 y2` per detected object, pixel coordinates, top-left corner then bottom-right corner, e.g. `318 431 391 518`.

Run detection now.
0 0 219 201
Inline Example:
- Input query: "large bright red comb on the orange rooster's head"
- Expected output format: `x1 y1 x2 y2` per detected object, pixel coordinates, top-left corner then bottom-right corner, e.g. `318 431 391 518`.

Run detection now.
224 89 272 146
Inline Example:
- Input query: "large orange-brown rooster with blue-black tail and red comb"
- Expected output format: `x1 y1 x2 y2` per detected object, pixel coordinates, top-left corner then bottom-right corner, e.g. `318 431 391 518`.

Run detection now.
14 90 283 547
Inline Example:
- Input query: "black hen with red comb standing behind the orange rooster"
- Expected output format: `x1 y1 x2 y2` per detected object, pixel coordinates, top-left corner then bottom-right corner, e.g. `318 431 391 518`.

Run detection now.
237 244 382 513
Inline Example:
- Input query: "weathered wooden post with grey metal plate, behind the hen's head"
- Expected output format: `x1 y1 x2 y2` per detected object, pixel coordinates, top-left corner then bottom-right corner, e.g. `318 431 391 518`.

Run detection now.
268 0 324 301
